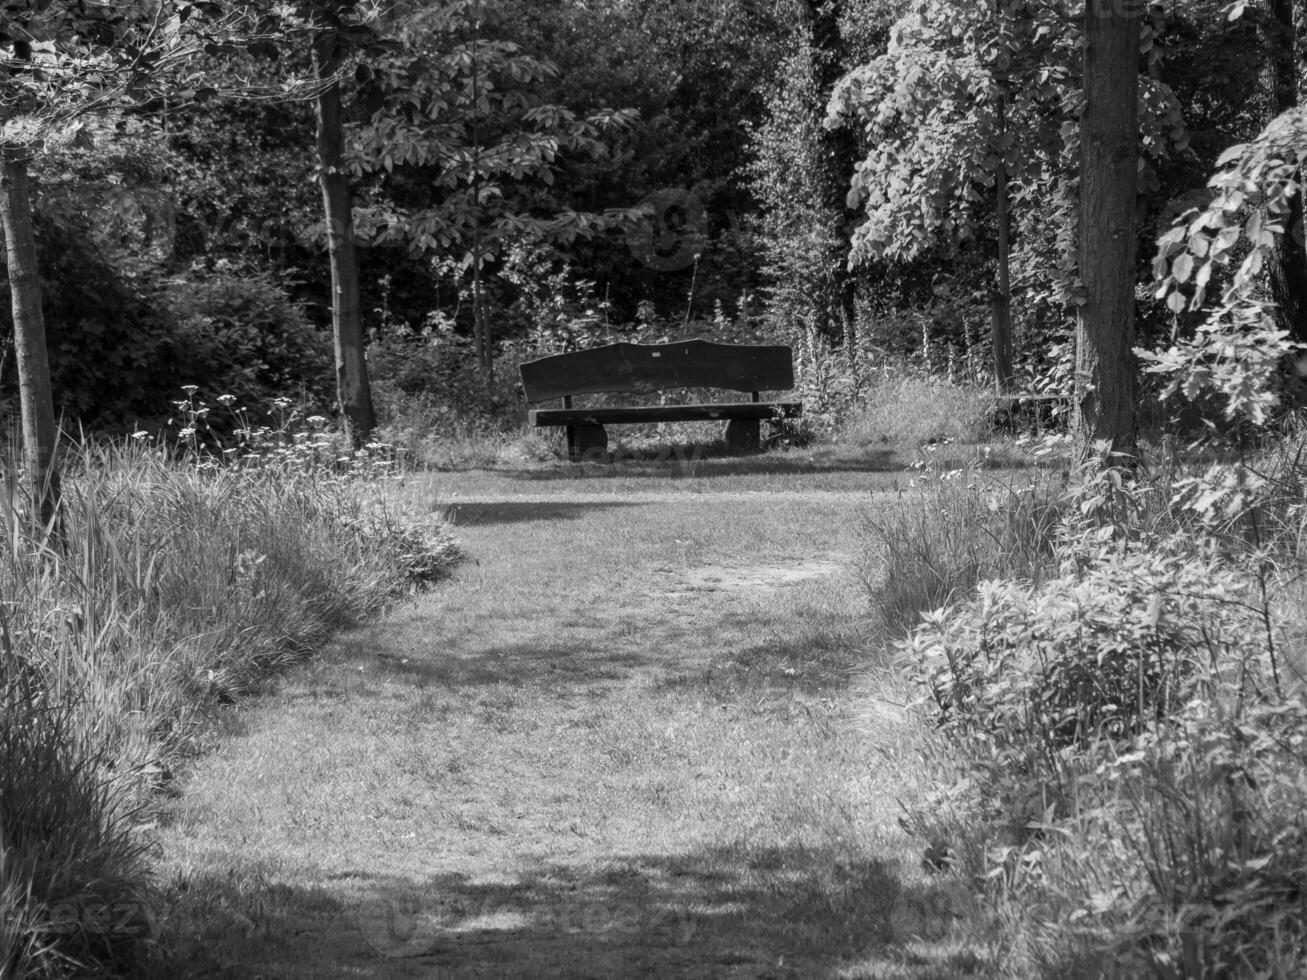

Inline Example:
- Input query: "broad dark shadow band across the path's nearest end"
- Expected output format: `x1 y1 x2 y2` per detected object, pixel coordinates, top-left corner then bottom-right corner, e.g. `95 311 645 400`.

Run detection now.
152 845 967 980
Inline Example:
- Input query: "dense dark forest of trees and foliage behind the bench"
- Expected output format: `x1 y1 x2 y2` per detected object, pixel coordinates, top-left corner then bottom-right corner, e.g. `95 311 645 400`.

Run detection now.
0 0 1286 433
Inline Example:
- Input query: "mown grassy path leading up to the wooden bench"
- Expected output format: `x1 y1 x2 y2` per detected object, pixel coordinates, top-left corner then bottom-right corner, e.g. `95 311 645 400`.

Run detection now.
150 473 972 980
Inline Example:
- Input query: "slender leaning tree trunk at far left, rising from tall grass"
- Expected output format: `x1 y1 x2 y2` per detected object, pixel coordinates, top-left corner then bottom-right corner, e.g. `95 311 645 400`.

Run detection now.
0 146 60 532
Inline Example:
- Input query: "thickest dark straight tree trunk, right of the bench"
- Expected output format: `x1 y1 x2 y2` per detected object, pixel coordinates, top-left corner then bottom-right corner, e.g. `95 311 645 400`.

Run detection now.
1074 0 1142 459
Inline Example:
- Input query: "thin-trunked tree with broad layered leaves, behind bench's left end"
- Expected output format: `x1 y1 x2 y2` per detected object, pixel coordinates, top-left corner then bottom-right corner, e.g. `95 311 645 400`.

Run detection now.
348 0 639 391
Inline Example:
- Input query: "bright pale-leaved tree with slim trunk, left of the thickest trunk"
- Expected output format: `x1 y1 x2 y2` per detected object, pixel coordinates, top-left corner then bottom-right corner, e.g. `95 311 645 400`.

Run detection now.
827 0 1072 388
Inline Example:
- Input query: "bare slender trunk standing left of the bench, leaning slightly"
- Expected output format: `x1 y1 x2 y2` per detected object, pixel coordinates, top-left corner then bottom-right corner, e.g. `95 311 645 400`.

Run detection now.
312 31 376 448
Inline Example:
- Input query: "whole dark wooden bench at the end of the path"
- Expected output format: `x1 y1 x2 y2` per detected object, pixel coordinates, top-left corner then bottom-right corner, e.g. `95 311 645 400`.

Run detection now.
521 340 802 461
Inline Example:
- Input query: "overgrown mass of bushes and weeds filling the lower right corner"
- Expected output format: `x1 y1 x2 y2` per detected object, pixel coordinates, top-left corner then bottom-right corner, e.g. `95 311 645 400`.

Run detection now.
888 448 1307 977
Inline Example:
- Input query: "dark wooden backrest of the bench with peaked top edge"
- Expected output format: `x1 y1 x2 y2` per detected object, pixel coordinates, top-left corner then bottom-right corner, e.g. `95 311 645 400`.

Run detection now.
521 340 795 402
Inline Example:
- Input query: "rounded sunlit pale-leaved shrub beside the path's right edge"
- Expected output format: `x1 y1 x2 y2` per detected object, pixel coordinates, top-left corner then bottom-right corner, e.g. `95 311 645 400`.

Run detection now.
907 542 1257 753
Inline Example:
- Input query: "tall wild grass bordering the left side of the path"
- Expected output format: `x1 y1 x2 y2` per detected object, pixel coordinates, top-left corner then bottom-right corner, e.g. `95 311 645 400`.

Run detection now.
0 443 454 980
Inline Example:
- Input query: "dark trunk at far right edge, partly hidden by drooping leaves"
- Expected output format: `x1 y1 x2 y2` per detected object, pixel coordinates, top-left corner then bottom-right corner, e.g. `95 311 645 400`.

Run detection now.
1264 0 1307 344
